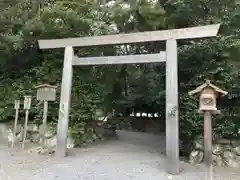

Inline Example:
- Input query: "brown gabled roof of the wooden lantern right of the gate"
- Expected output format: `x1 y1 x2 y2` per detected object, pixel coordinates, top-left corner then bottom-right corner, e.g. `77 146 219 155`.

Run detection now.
188 80 228 96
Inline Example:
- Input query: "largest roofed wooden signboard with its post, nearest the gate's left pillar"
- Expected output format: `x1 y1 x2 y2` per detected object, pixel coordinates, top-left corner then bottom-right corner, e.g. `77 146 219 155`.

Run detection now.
35 84 57 145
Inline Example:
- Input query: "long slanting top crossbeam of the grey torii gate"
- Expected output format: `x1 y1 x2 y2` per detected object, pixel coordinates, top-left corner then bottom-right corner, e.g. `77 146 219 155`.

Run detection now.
38 24 220 49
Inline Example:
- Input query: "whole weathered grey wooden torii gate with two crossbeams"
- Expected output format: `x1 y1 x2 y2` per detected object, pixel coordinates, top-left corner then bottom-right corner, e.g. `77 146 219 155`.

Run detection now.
38 24 220 174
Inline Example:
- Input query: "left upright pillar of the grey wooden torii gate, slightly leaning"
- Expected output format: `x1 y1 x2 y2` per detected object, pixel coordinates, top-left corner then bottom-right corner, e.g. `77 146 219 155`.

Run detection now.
55 47 74 157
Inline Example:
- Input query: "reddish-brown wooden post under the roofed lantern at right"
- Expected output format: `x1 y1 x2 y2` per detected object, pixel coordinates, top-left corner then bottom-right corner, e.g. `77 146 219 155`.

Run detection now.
204 111 213 180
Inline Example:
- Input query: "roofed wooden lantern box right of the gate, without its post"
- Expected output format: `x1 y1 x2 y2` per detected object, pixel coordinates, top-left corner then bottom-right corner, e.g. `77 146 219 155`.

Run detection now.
189 80 227 111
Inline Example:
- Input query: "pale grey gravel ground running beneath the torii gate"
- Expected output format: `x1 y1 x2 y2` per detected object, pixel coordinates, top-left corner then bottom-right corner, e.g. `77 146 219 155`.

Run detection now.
0 131 240 180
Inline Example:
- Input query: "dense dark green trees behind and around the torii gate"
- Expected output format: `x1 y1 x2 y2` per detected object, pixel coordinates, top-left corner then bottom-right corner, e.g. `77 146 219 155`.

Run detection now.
0 0 240 148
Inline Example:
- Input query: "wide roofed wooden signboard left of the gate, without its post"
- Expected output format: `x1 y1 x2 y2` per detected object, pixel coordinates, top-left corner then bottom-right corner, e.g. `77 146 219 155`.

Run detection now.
36 84 57 101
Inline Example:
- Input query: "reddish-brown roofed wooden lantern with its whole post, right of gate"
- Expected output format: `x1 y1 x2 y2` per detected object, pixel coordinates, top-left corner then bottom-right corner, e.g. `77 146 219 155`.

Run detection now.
189 80 227 178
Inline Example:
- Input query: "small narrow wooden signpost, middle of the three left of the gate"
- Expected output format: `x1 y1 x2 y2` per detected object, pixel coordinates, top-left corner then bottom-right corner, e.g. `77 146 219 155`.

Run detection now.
22 96 32 148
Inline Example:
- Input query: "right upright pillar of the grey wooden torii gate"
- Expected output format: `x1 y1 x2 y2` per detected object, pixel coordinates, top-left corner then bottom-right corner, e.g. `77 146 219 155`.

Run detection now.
166 39 180 175
